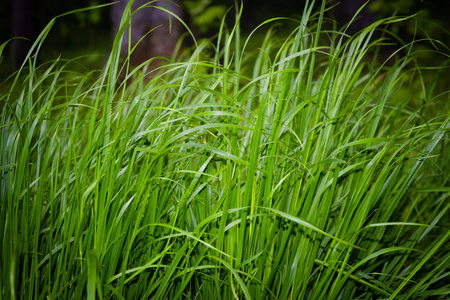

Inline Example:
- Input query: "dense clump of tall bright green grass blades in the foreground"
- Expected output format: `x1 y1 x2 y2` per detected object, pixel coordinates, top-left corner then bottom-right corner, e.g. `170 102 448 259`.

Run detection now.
0 1 450 299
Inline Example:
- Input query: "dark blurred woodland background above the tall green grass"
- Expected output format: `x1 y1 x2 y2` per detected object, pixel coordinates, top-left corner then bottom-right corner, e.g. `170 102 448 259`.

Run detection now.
0 0 450 73
